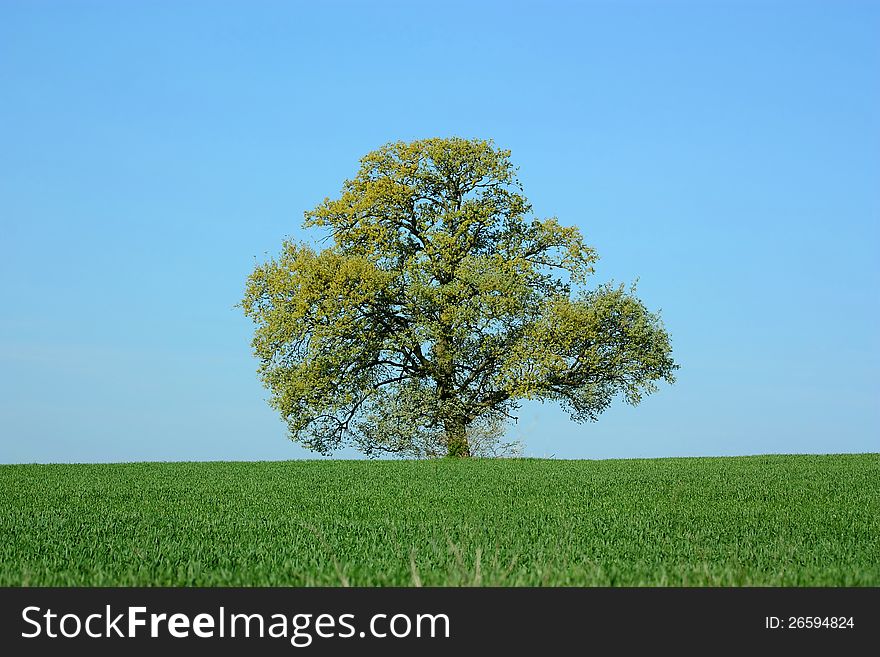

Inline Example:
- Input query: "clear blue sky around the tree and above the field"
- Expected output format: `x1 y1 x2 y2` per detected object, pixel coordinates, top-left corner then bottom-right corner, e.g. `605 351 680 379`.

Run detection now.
0 0 880 463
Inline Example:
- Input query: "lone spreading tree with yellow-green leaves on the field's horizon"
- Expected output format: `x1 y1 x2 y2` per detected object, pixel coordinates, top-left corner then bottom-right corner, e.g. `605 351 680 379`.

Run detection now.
242 138 678 456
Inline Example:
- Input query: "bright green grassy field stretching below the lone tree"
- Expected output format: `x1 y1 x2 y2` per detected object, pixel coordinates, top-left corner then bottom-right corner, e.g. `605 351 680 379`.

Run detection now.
0 454 880 586
